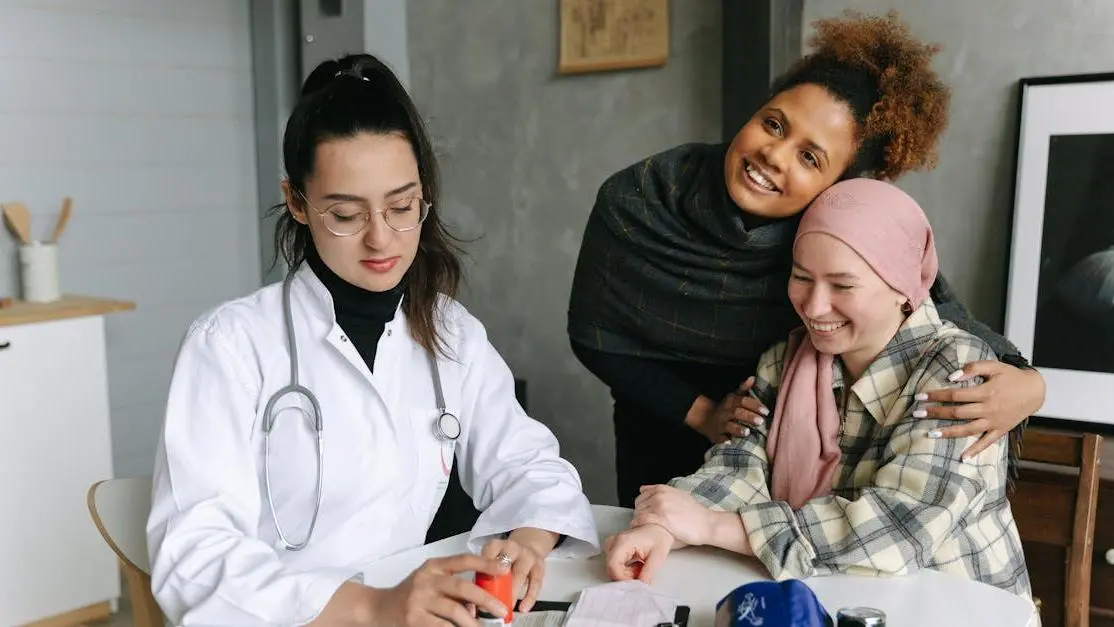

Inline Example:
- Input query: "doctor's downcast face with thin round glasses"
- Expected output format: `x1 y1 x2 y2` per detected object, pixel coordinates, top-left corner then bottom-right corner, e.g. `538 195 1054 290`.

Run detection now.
283 133 422 292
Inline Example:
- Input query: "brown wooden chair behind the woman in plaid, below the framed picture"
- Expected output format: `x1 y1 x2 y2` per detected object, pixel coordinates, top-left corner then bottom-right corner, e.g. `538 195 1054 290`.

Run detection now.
1009 428 1102 627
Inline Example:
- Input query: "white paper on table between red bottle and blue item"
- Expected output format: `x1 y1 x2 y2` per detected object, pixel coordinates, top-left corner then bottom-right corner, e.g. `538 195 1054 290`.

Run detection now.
565 581 677 627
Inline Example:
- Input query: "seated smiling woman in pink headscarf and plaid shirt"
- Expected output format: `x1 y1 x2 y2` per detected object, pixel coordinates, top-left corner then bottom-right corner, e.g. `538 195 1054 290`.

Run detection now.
606 178 1030 597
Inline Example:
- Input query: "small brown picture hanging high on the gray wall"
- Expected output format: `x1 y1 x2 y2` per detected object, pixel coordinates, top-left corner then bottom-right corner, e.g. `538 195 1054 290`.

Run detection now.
557 0 670 74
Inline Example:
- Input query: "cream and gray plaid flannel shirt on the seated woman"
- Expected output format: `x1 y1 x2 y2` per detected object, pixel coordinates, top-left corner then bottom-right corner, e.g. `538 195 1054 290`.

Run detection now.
671 301 1030 597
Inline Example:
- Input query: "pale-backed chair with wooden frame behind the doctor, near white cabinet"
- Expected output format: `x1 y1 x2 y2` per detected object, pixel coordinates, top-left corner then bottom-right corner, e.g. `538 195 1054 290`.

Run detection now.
86 477 166 627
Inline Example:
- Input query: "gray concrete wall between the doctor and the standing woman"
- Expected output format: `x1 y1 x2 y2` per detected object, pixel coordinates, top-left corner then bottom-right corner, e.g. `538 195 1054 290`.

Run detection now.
408 0 721 502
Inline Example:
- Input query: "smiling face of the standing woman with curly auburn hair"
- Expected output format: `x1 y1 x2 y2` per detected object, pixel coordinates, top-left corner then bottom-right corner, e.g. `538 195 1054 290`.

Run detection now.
724 84 856 218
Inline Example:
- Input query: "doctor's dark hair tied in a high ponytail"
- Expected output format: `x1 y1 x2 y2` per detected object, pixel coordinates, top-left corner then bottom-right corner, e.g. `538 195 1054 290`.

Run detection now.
273 55 462 353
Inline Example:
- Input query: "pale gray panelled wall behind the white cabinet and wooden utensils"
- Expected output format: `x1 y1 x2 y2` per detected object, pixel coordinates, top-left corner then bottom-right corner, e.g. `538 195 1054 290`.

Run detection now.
0 0 260 474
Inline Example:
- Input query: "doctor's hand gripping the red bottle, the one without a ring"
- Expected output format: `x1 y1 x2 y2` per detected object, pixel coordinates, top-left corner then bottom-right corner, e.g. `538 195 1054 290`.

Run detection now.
370 555 507 627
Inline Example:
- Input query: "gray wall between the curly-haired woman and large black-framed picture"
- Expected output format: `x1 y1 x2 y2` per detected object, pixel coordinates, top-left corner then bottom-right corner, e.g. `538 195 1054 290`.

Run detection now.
803 0 1114 477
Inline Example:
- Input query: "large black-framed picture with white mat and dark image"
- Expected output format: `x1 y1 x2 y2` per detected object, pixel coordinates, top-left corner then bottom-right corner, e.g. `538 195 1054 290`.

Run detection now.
1005 74 1114 431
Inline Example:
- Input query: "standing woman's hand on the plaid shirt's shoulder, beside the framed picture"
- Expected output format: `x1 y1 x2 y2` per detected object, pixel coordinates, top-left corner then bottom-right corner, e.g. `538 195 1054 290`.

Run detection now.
915 361 1045 459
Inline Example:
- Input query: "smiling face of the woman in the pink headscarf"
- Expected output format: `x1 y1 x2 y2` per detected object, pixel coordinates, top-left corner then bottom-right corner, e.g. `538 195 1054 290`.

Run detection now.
789 233 907 378
